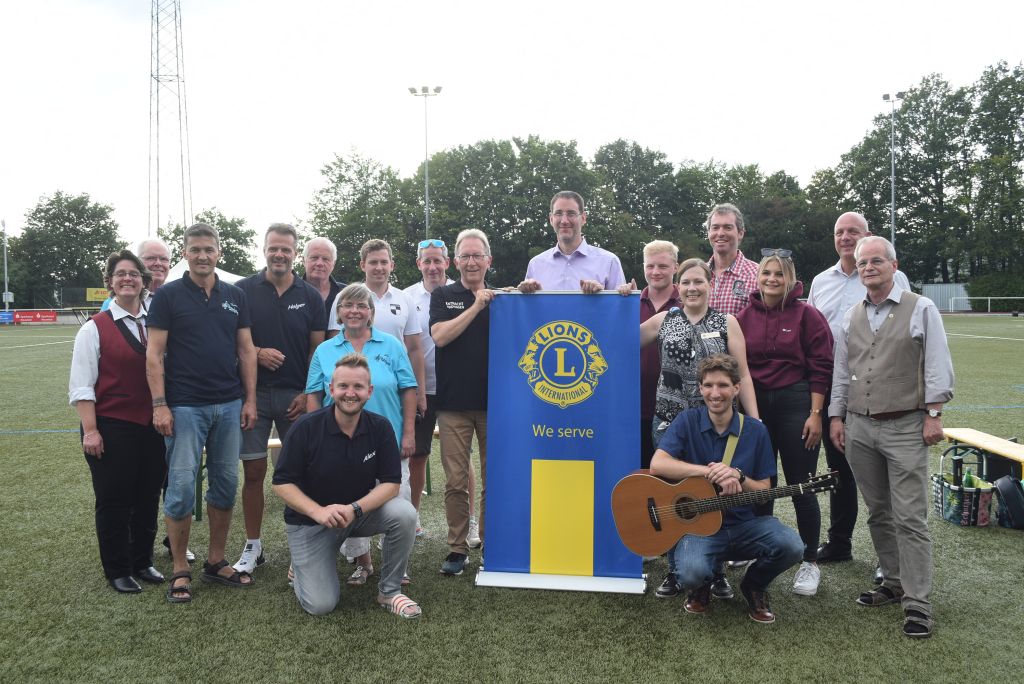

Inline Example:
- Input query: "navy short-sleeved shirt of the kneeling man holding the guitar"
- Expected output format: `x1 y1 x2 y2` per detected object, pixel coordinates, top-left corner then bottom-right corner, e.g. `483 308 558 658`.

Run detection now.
657 407 775 527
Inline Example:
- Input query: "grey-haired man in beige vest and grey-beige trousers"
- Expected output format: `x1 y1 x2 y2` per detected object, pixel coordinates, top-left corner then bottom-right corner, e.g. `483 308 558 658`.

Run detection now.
828 236 953 638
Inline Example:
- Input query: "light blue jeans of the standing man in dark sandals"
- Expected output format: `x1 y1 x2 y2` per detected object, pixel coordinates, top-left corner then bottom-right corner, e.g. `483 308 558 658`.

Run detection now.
164 399 242 520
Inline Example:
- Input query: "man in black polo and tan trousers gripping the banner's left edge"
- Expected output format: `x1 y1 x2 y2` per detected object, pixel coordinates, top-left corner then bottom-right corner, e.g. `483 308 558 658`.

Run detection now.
430 228 495 574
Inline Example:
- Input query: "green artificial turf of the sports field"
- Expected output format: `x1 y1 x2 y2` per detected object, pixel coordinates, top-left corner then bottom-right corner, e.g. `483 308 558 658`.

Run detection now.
0 316 1024 684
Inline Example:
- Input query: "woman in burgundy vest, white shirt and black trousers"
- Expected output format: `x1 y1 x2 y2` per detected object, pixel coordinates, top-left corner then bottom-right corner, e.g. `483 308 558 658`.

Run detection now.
68 250 167 594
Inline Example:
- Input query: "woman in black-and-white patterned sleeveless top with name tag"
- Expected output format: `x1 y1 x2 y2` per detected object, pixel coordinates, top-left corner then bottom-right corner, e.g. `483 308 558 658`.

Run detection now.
640 259 758 598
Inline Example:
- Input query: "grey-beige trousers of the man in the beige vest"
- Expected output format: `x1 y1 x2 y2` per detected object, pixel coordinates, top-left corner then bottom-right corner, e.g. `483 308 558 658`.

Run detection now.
846 412 932 616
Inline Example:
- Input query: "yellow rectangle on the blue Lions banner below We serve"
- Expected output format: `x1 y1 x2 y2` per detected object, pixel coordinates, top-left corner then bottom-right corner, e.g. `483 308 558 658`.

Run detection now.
529 459 594 575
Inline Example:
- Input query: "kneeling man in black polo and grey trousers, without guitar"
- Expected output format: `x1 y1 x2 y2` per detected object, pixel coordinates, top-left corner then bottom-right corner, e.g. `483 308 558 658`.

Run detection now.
273 353 421 617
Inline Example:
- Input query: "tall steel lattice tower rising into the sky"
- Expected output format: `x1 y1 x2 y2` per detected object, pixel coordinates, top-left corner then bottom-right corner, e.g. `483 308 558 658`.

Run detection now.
147 0 193 236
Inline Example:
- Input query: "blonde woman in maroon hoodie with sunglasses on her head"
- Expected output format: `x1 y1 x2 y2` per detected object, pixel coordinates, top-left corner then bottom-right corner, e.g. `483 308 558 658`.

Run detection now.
736 249 833 596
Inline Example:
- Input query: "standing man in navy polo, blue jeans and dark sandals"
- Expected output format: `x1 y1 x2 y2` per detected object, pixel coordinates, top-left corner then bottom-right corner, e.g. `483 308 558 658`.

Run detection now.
145 223 256 603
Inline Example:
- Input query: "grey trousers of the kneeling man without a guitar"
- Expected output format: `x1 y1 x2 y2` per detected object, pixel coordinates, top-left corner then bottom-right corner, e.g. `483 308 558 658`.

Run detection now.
285 497 416 615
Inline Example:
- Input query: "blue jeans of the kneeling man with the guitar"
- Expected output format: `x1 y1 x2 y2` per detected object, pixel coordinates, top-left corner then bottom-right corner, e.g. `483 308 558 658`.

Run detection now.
675 515 804 592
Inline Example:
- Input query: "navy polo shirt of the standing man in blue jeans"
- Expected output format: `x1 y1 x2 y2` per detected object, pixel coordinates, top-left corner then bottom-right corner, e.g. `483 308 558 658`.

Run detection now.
146 271 249 407
